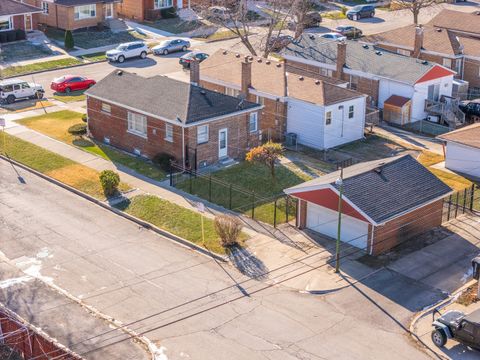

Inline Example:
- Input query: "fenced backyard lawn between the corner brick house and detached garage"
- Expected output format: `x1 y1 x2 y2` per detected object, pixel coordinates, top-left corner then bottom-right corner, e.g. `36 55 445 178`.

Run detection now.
177 162 310 224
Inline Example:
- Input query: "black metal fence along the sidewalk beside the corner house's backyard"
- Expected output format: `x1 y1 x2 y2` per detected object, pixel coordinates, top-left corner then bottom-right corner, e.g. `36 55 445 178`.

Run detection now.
170 163 298 227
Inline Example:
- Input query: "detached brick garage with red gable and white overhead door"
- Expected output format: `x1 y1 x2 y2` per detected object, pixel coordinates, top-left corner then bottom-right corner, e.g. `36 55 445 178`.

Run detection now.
285 155 452 255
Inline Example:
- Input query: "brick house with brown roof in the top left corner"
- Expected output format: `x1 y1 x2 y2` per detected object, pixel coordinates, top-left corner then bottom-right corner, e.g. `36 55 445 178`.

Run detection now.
0 0 42 32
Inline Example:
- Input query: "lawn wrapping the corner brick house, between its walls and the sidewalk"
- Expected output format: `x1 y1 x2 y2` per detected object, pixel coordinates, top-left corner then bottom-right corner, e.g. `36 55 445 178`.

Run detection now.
18 110 165 181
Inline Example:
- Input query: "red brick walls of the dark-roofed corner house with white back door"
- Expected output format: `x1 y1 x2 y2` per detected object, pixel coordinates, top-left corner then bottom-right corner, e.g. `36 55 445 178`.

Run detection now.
87 97 261 166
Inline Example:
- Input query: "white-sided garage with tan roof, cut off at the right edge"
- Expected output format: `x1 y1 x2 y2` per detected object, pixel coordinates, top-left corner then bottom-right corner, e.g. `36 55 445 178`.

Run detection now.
438 123 480 180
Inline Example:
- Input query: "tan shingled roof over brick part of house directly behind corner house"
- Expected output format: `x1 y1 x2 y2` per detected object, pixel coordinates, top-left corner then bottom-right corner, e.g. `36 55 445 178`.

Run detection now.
200 49 345 97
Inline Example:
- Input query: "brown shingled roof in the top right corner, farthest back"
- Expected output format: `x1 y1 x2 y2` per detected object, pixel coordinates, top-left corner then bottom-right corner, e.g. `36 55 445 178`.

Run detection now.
428 9 480 35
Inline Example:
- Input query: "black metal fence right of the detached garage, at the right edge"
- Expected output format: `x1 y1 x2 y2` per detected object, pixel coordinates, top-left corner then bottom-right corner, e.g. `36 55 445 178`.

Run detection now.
443 184 480 222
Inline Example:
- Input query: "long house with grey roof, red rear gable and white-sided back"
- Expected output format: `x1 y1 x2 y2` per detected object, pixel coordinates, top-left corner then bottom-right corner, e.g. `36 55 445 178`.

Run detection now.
281 34 455 122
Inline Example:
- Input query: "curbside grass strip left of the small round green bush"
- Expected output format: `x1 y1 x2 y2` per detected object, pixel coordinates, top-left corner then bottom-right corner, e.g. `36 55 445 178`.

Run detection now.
0 134 129 200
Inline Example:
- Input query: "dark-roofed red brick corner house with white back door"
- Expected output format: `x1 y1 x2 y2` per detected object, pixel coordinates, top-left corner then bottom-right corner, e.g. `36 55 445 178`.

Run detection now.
86 71 262 168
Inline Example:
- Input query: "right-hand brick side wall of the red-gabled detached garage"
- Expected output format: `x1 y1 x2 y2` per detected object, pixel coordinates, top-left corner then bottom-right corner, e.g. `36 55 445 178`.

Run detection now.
372 200 443 255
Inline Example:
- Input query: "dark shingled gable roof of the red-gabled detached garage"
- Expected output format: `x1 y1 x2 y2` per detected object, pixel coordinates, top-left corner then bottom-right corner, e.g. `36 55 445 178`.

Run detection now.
285 155 452 224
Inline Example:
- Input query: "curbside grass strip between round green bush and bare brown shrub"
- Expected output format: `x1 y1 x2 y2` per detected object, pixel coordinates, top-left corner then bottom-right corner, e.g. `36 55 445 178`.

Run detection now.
117 195 247 255
